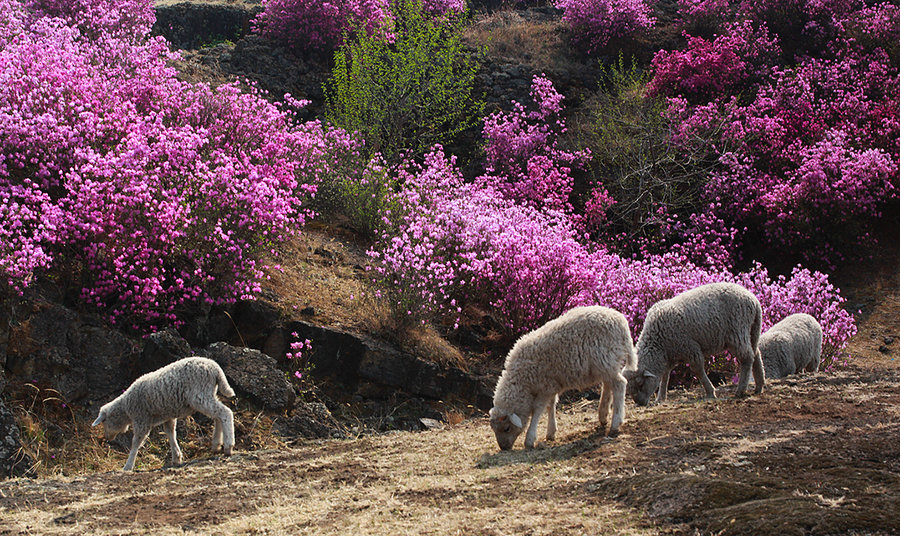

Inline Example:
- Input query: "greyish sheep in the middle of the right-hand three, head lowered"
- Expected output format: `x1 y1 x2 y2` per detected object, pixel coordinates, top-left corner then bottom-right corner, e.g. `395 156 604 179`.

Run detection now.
626 283 765 406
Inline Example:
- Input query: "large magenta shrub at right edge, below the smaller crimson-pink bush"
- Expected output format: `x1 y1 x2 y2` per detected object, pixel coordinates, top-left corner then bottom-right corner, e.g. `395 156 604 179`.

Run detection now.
669 45 900 265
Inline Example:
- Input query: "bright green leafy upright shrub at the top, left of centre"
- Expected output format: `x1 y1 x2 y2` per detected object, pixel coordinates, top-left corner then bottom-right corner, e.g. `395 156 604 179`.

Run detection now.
325 0 482 163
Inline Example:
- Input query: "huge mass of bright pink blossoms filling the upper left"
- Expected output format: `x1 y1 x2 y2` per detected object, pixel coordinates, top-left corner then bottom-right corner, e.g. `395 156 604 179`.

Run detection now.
0 0 355 329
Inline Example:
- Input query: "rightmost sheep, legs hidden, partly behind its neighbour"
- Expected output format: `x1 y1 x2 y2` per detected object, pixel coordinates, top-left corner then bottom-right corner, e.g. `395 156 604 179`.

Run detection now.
759 313 822 378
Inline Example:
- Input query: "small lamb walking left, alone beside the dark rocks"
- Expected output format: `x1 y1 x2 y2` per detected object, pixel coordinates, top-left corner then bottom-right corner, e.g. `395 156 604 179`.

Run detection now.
92 357 234 471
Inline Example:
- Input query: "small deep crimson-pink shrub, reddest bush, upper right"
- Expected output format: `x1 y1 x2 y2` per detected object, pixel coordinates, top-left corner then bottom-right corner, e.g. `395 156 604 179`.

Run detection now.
647 20 779 101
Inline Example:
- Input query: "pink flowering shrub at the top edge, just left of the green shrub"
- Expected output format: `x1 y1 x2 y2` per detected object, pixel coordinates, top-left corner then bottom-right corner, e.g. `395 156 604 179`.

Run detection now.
253 0 393 50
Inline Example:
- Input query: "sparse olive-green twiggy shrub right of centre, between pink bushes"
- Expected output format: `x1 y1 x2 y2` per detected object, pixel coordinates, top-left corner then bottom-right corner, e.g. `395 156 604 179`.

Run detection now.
576 57 717 262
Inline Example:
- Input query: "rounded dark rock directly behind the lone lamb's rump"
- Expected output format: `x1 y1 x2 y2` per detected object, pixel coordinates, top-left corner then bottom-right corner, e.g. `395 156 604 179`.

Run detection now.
198 342 297 411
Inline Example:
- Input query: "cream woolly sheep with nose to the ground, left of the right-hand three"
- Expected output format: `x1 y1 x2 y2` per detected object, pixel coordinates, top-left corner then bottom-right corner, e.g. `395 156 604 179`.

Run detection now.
490 306 637 450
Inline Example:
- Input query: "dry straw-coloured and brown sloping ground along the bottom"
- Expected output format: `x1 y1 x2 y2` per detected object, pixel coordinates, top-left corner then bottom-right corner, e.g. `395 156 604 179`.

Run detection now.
0 356 900 535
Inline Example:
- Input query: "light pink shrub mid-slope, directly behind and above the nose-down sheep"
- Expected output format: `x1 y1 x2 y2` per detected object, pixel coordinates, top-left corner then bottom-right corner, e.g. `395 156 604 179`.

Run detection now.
370 147 591 333
